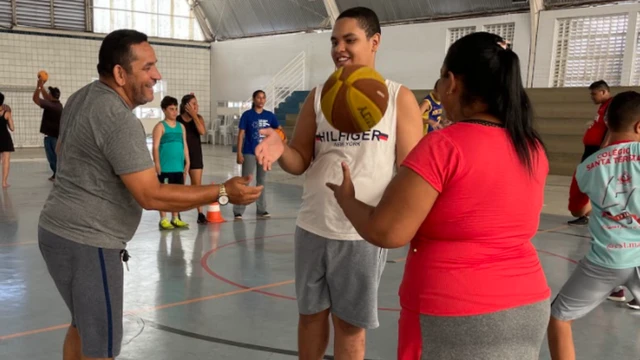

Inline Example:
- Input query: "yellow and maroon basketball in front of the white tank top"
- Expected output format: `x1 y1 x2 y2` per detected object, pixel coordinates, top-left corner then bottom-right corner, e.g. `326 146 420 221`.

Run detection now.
320 65 389 133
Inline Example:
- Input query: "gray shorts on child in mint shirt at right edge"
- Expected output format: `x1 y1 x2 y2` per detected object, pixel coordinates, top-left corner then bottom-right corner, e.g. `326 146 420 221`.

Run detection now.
551 259 640 321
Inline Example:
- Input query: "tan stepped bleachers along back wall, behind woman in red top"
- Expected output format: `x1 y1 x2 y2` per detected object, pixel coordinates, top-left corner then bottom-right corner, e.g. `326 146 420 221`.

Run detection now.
276 87 640 175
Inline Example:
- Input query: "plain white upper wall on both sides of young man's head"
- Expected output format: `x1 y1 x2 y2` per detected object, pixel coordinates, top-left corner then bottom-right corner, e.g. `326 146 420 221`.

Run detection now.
211 13 531 101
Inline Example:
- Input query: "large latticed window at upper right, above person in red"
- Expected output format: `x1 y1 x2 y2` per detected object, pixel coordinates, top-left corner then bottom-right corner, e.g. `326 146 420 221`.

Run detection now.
553 14 629 87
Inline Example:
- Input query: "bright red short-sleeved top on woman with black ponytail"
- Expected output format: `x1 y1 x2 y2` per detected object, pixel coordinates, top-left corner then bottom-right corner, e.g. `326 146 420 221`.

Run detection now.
400 123 550 316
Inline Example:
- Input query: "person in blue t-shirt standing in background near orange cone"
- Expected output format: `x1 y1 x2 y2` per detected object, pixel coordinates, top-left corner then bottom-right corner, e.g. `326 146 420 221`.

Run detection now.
233 90 282 220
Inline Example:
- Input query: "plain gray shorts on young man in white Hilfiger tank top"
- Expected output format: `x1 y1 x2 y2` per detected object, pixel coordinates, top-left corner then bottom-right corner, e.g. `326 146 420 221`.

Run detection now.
295 227 388 329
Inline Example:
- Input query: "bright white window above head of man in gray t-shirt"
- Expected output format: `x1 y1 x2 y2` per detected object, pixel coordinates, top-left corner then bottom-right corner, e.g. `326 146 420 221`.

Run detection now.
93 0 204 41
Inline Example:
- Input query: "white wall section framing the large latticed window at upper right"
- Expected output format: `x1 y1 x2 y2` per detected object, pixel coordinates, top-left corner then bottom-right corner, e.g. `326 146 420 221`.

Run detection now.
533 4 640 87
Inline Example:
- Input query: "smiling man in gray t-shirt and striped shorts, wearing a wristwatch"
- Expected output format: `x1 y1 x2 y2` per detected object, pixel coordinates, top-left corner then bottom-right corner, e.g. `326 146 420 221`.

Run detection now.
38 30 262 359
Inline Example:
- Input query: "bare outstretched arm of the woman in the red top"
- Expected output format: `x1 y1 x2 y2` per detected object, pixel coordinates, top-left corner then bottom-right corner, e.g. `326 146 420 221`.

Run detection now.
327 163 439 248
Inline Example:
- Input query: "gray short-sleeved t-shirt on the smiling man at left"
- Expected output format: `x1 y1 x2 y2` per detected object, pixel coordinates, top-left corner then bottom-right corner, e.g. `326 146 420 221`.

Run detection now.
40 81 154 249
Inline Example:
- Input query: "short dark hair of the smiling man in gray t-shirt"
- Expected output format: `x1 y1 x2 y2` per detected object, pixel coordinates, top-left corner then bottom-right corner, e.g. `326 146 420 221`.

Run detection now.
98 29 148 77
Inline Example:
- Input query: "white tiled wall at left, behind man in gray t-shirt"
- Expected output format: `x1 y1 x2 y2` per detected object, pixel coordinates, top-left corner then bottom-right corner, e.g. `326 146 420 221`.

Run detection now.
0 29 211 146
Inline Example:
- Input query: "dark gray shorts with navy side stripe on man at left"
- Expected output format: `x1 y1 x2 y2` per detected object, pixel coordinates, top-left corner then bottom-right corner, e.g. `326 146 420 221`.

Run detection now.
38 227 123 358
